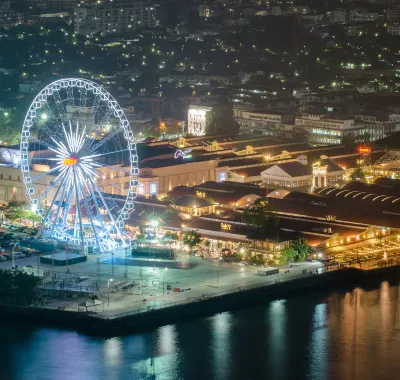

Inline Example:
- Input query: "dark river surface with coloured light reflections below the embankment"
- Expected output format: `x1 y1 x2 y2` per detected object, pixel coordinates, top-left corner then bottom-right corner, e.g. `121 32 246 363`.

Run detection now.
0 282 400 380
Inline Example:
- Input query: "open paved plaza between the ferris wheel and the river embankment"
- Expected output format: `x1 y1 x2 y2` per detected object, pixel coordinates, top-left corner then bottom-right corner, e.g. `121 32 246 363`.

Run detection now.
0 246 324 318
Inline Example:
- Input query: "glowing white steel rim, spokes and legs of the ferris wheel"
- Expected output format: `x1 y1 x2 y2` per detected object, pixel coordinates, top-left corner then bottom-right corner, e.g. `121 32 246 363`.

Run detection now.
20 78 138 251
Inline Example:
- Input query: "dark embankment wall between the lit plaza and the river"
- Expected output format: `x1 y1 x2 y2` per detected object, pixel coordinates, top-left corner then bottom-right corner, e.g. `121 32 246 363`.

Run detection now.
0 266 400 336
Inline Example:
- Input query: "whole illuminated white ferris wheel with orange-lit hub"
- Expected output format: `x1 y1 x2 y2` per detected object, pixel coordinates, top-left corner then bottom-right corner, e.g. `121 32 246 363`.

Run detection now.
21 79 138 252
